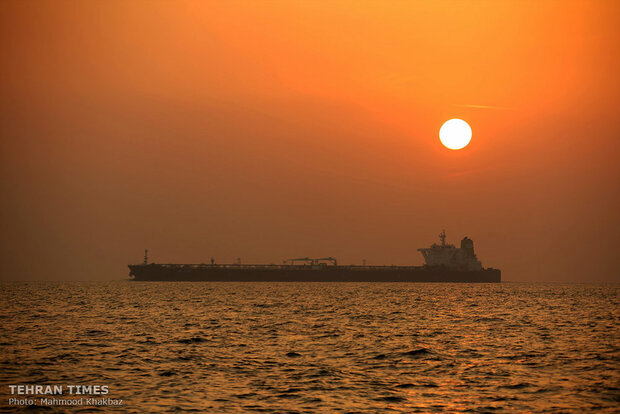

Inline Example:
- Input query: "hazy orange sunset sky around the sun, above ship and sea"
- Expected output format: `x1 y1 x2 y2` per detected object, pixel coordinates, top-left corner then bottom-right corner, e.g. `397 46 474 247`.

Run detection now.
0 0 620 282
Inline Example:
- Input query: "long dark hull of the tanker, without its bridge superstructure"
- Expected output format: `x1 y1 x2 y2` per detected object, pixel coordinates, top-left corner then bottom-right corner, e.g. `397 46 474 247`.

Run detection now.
129 264 501 283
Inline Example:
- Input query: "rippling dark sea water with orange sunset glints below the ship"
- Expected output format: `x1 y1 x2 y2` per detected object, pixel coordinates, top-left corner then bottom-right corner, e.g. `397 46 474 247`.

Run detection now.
0 281 620 413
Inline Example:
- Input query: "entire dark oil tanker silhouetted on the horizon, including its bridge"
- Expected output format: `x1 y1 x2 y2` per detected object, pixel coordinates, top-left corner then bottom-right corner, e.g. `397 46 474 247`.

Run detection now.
129 230 501 283
